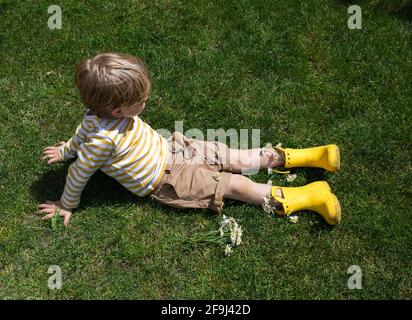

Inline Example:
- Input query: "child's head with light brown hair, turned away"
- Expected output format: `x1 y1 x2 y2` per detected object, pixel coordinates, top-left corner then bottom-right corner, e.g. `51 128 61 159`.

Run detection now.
75 53 151 118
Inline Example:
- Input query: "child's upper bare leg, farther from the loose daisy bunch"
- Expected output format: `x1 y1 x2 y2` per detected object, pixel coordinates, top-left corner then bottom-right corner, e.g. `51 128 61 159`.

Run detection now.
224 148 285 172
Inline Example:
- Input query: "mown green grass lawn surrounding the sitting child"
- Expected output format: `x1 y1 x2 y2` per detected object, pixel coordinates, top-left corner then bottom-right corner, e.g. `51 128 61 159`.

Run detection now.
0 0 412 299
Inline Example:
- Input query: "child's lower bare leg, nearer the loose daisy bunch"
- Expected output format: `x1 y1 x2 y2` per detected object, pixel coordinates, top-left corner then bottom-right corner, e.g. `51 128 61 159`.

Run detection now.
223 174 282 207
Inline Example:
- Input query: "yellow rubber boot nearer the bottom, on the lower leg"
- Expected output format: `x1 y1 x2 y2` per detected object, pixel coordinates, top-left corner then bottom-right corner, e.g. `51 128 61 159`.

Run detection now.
271 181 341 225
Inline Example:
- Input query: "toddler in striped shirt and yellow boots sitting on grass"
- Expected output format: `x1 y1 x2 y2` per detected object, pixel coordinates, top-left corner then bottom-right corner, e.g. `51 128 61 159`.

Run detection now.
39 53 341 226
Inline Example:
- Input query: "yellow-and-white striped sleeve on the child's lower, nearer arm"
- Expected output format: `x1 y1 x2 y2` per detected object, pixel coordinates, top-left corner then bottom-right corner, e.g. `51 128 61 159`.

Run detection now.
60 134 115 209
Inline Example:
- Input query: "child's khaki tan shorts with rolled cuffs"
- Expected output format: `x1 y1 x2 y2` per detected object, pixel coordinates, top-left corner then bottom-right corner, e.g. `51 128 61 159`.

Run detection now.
150 132 232 212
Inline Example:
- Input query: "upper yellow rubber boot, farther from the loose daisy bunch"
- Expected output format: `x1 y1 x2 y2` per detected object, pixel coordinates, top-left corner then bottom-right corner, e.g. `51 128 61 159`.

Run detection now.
279 144 340 172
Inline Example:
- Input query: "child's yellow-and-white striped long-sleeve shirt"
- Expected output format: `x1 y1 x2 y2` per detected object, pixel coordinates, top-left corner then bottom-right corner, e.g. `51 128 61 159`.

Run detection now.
59 113 168 208
